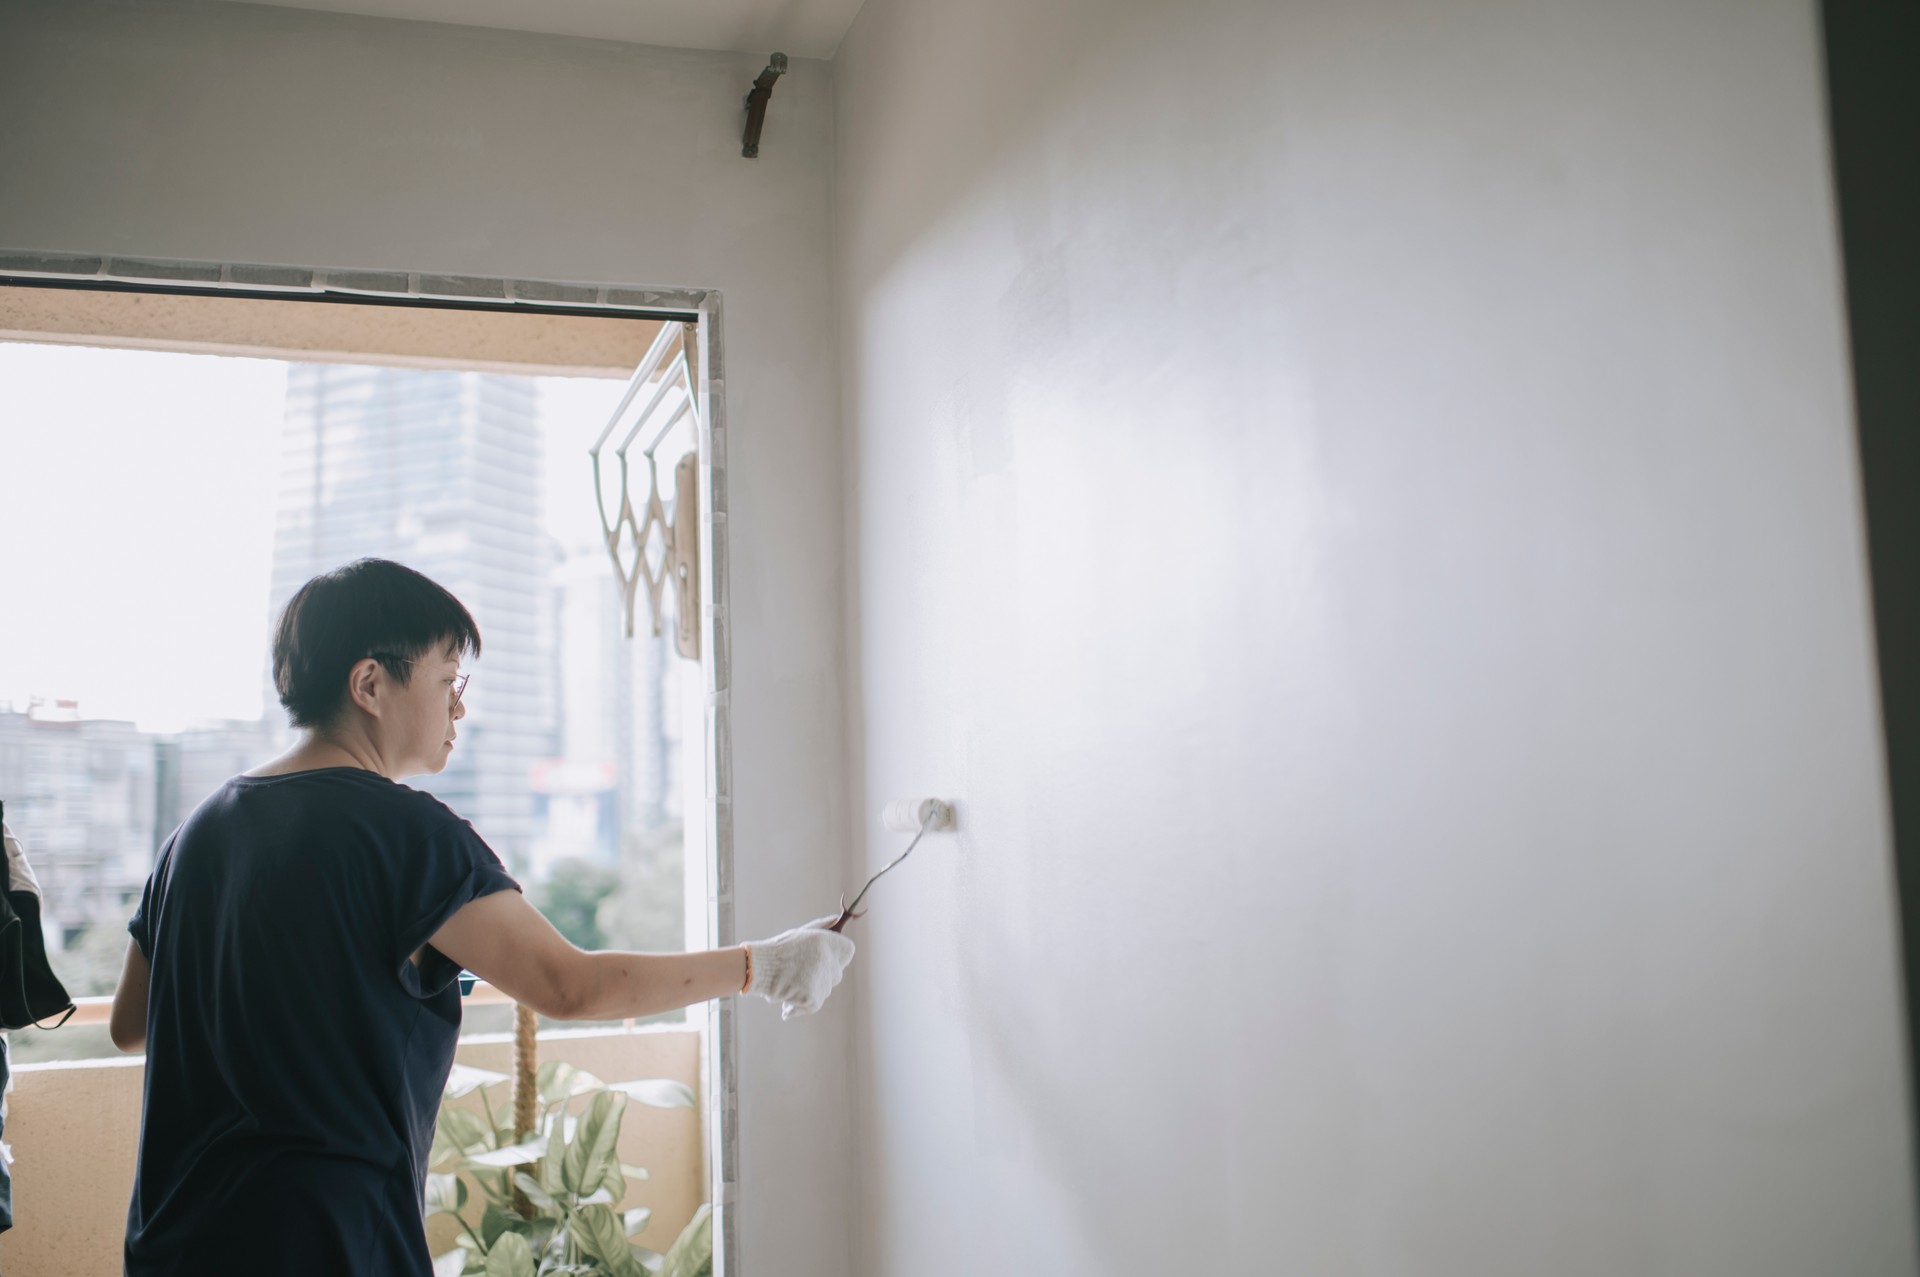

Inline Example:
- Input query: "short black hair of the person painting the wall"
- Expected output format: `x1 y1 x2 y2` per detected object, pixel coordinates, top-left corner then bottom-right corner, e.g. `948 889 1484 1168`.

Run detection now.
273 559 480 728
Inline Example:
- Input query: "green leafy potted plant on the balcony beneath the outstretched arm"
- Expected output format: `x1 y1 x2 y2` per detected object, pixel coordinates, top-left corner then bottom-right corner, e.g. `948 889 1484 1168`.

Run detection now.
426 1062 712 1277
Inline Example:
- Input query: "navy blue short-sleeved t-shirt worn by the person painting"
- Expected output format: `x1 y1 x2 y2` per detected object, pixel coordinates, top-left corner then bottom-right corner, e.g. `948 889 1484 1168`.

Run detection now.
127 768 518 1277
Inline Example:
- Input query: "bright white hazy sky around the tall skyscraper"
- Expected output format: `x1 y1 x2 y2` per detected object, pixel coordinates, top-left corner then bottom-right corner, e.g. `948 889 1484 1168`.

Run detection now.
0 342 620 732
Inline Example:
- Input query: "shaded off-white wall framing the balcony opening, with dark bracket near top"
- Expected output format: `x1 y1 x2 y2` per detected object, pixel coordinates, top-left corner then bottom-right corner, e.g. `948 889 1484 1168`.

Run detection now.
0 0 849 1277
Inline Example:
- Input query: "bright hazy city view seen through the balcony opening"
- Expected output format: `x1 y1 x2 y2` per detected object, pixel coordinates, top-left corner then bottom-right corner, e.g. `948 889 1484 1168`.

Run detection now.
0 336 708 1044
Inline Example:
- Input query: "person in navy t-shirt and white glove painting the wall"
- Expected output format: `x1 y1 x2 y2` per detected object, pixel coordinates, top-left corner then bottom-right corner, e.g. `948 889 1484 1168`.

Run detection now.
111 559 852 1277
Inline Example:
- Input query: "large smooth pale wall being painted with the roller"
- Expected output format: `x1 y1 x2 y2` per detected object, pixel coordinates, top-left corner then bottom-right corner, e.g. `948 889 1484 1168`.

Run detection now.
835 0 1914 1277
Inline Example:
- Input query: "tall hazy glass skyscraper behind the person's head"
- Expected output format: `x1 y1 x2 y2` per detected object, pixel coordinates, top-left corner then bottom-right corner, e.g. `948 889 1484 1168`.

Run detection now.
269 365 555 866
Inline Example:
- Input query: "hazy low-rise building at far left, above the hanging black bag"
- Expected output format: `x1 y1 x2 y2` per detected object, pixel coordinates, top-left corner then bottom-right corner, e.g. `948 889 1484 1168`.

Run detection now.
0 701 156 945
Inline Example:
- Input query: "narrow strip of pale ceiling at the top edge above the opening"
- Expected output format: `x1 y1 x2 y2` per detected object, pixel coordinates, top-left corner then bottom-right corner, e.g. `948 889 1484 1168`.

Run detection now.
228 0 862 58
